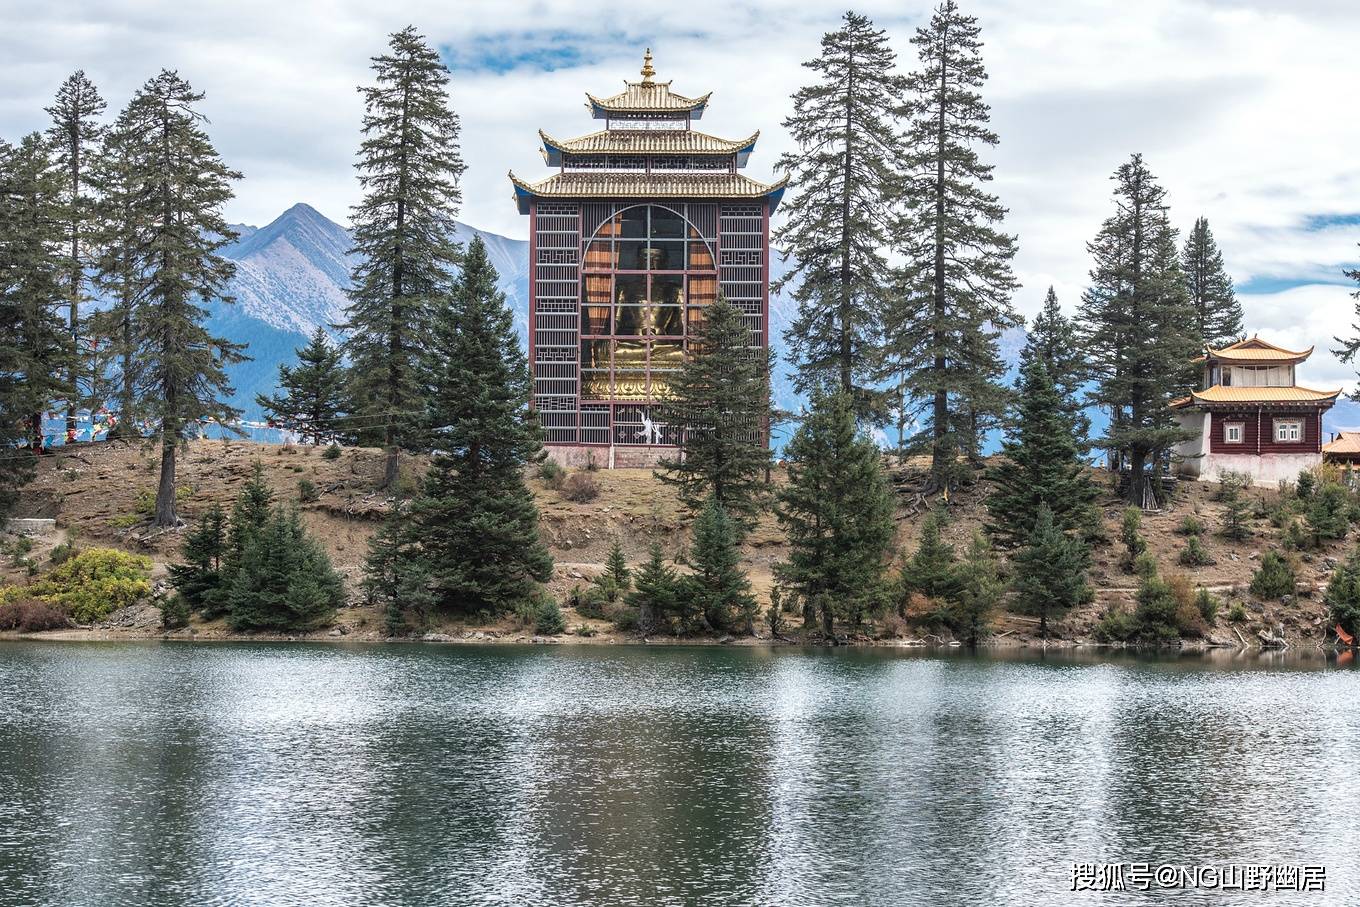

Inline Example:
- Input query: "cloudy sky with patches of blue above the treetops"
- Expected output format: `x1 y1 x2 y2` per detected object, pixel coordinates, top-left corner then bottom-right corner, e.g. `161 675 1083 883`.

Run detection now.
0 0 1360 386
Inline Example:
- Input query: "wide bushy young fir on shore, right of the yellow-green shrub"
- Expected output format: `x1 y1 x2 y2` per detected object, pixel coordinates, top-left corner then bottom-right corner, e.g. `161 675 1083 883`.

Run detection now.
227 507 344 631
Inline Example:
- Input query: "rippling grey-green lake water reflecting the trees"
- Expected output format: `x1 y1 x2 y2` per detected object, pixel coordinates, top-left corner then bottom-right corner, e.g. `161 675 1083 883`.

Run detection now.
0 642 1360 907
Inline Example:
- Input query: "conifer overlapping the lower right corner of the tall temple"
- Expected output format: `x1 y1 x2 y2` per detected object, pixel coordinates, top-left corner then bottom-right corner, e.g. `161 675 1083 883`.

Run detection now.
657 299 774 532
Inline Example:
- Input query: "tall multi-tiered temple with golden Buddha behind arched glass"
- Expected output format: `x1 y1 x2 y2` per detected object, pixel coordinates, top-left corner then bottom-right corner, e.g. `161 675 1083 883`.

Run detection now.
510 52 785 466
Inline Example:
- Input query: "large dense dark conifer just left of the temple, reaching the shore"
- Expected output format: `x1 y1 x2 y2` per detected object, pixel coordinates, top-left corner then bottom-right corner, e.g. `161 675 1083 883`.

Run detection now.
397 237 552 612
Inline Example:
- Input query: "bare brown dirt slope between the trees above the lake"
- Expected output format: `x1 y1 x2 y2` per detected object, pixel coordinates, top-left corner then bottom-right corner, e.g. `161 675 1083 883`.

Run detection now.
3 441 1349 645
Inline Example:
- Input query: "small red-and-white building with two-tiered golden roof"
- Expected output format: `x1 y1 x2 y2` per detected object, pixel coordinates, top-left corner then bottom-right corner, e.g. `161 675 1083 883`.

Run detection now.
1171 337 1341 485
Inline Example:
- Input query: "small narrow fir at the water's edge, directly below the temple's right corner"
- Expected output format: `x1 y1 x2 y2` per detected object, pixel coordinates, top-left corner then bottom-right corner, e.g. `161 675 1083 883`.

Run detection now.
680 498 756 634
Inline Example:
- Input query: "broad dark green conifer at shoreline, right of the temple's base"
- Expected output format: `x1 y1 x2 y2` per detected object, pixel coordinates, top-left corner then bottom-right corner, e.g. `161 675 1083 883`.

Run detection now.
777 392 895 635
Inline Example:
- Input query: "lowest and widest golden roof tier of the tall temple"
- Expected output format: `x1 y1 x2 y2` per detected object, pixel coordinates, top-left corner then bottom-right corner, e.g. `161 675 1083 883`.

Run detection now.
510 170 789 208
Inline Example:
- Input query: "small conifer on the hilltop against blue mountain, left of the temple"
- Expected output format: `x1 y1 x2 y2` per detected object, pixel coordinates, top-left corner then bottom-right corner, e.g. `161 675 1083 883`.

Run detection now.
256 328 345 445
